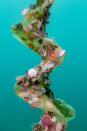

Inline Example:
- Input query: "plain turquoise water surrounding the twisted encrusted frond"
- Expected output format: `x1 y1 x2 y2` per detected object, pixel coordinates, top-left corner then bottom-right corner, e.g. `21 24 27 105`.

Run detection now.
0 0 87 131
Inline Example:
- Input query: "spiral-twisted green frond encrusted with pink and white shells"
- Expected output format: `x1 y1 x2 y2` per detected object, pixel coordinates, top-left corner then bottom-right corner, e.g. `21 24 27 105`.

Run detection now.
11 0 75 131
